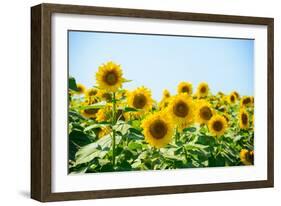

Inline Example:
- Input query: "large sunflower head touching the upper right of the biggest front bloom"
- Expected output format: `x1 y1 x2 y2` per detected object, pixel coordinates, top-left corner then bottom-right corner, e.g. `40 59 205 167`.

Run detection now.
167 93 195 129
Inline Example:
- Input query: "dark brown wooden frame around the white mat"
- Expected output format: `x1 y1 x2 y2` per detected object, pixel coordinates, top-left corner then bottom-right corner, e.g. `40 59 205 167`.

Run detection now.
31 4 274 202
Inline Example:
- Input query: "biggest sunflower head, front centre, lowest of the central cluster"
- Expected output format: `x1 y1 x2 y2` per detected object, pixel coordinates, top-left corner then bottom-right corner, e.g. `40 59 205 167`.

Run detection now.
141 112 174 148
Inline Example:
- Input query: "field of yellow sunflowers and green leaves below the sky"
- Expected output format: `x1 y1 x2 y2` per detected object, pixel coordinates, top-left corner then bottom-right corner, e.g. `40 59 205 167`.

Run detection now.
68 61 254 174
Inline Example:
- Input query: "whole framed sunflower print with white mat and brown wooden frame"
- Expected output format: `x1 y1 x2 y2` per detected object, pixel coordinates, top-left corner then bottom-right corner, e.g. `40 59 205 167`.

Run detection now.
31 4 274 202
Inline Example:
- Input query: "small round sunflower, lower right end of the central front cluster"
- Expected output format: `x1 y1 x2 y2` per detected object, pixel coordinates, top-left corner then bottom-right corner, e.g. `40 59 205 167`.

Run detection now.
208 114 227 137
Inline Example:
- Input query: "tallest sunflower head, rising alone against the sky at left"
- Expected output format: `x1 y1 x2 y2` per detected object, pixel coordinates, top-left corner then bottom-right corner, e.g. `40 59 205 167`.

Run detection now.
96 61 124 92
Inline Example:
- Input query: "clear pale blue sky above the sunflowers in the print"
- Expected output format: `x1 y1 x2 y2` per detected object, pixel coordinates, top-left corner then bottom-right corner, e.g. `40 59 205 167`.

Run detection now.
69 31 254 100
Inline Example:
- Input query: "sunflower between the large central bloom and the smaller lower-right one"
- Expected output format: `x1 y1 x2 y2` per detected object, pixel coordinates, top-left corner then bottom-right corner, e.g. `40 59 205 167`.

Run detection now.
195 100 213 124
